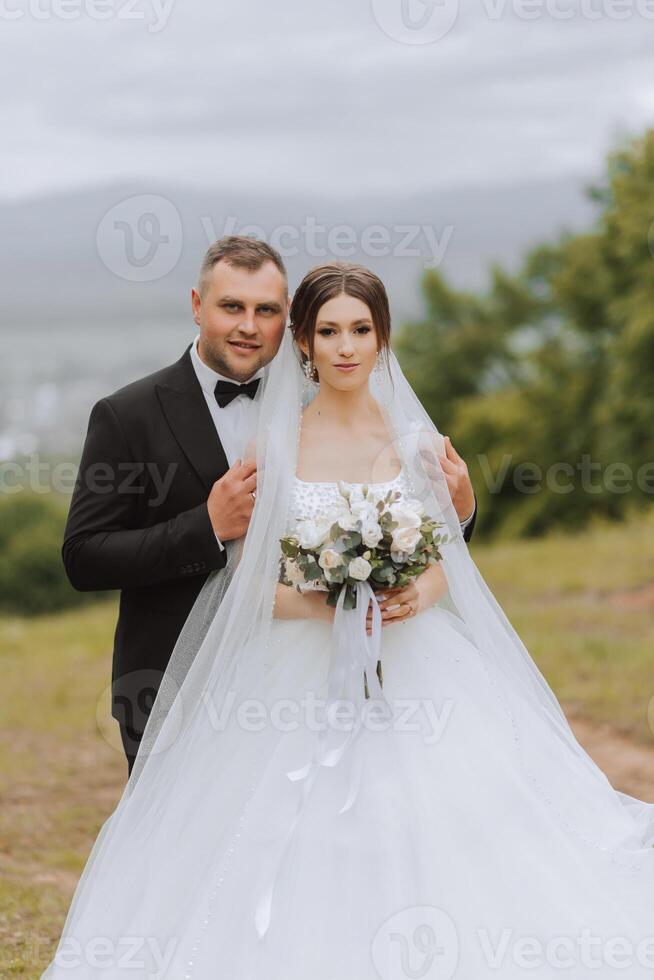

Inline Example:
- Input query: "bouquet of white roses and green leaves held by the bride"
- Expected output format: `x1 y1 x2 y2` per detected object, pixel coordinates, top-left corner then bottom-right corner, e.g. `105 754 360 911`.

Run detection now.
280 482 447 609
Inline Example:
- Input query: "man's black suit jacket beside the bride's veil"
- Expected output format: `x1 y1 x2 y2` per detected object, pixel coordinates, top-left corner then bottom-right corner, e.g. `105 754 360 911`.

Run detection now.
62 344 476 732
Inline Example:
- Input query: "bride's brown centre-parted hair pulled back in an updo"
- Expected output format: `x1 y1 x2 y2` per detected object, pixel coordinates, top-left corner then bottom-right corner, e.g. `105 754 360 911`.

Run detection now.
290 262 391 381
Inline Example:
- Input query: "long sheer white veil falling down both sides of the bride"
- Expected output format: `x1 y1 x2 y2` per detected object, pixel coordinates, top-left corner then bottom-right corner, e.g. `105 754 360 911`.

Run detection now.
44 330 654 977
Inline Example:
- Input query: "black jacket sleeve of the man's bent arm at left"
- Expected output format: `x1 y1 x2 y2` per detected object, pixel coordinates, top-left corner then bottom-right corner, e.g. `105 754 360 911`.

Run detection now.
61 399 226 592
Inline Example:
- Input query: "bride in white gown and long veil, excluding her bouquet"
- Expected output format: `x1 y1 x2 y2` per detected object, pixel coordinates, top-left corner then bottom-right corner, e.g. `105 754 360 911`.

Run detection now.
43 263 654 980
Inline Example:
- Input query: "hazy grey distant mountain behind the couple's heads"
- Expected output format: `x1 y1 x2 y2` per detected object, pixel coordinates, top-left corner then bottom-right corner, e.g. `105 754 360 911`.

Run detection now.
0 179 596 326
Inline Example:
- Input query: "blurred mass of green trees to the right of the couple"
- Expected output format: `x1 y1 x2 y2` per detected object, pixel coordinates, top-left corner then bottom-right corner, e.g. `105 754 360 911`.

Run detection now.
396 131 654 534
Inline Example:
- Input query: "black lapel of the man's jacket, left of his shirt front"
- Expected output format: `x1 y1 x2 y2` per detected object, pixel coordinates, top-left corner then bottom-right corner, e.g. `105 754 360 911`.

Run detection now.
155 344 229 493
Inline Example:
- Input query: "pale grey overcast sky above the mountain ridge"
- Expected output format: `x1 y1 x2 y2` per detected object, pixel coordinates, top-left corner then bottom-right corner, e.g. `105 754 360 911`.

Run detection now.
0 0 654 198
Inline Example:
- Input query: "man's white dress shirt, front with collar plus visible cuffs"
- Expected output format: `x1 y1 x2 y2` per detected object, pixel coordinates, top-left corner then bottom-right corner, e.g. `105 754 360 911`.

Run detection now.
191 334 475 548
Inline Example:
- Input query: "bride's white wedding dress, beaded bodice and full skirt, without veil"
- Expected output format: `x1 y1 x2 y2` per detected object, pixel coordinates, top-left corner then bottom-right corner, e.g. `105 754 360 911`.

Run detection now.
161 474 654 980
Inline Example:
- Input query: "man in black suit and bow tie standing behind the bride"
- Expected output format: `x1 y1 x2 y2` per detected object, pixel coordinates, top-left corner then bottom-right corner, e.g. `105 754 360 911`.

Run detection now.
62 236 476 773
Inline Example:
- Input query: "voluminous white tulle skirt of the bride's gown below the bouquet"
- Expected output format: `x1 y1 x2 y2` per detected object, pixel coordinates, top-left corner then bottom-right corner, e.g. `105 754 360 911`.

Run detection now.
45 607 654 980
